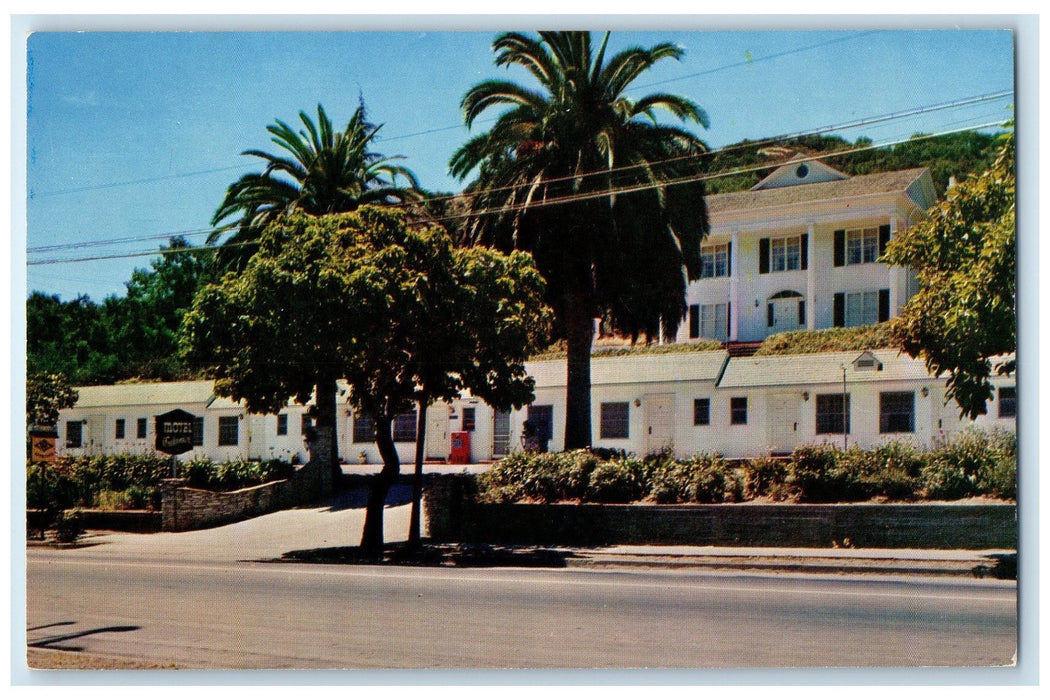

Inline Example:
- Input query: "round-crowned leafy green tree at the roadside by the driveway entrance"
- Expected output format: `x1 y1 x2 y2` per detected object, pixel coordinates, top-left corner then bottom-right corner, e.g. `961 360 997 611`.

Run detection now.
184 207 546 554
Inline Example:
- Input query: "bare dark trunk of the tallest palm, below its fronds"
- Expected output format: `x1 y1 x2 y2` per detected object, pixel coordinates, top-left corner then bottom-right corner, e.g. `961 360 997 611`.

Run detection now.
564 291 594 450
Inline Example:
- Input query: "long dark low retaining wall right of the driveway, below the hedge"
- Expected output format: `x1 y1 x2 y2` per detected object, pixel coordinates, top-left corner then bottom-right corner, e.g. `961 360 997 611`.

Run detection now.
426 476 1017 549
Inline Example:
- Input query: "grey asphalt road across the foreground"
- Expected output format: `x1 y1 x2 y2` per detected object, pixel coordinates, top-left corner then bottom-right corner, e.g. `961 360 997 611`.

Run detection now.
26 547 1017 669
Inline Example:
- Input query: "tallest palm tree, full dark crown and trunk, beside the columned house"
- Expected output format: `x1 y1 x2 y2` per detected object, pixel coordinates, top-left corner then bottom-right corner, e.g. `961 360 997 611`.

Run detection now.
449 31 708 449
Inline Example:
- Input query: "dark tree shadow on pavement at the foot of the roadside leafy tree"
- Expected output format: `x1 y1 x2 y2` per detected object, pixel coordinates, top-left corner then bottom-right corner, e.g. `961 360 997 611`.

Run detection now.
273 544 576 569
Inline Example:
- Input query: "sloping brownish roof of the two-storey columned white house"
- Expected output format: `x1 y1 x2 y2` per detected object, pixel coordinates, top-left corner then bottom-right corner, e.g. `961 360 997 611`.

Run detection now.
705 168 935 217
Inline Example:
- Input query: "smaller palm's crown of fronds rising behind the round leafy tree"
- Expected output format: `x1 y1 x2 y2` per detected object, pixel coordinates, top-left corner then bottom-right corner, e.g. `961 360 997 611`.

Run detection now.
208 104 419 269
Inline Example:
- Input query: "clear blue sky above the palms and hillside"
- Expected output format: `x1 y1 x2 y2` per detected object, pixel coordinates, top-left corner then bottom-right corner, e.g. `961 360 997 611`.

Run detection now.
25 28 1014 301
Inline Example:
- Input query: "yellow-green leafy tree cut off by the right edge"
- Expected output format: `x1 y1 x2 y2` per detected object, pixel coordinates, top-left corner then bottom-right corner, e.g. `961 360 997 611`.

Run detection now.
884 128 1017 418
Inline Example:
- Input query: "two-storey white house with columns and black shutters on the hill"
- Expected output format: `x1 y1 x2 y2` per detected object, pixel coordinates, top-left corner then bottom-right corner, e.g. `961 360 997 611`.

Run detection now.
676 161 937 342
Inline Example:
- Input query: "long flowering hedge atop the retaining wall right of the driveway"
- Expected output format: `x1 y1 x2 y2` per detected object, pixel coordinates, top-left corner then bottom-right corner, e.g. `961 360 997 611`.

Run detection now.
478 430 1017 504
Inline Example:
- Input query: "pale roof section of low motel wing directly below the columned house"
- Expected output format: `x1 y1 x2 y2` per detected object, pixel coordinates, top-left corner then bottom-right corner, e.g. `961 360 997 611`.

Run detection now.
718 347 937 388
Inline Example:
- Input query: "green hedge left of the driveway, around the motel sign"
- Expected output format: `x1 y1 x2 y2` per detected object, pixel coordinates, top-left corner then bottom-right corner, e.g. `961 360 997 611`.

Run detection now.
25 454 295 510
